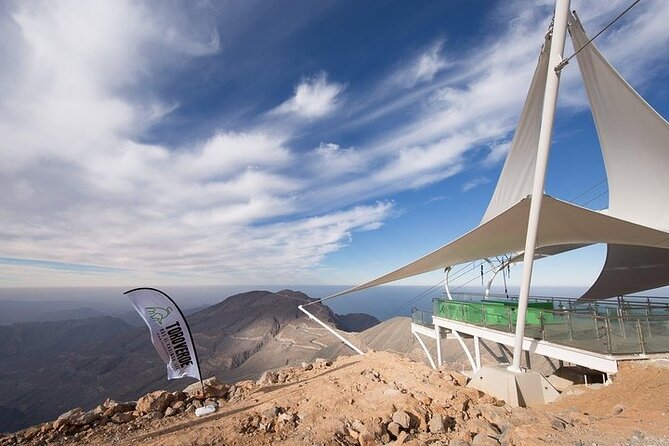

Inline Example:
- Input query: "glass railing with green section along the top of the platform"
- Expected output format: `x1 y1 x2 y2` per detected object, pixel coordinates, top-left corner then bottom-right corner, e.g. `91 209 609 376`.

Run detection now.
412 299 669 355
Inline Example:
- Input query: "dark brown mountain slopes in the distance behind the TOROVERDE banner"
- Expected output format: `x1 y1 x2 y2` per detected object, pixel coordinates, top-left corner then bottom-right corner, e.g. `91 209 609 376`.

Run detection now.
0 290 378 432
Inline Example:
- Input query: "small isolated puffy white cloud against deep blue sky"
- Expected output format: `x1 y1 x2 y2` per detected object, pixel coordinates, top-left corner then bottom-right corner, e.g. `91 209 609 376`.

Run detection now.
274 72 344 119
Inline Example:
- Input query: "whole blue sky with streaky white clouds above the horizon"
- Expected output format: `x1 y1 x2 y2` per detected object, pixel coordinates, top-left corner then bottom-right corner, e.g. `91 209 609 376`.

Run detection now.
0 0 669 287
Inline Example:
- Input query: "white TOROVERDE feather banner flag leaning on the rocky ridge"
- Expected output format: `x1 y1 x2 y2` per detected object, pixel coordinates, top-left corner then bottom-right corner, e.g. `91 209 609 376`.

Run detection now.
123 288 202 382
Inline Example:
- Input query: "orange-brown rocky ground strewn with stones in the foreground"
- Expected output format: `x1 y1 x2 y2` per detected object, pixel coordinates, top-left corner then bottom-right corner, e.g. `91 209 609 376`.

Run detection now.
0 352 669 446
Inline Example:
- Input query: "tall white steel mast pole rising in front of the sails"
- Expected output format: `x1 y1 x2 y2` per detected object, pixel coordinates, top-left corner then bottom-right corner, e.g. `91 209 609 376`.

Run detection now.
508 0 570 373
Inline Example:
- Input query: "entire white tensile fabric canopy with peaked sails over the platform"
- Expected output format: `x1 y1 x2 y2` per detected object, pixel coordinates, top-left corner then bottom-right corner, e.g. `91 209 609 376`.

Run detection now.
330 12 669 299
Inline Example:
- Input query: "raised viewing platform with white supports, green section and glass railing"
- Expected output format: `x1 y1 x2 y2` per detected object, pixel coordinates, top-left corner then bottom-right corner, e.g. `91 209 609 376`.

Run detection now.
412 294 669 373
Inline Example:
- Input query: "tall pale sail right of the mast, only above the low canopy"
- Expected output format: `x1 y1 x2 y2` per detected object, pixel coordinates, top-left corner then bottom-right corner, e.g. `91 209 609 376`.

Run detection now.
569 14 669 231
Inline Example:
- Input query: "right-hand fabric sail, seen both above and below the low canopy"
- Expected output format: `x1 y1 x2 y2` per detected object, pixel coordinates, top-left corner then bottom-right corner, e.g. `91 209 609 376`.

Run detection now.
570 17 669 300
